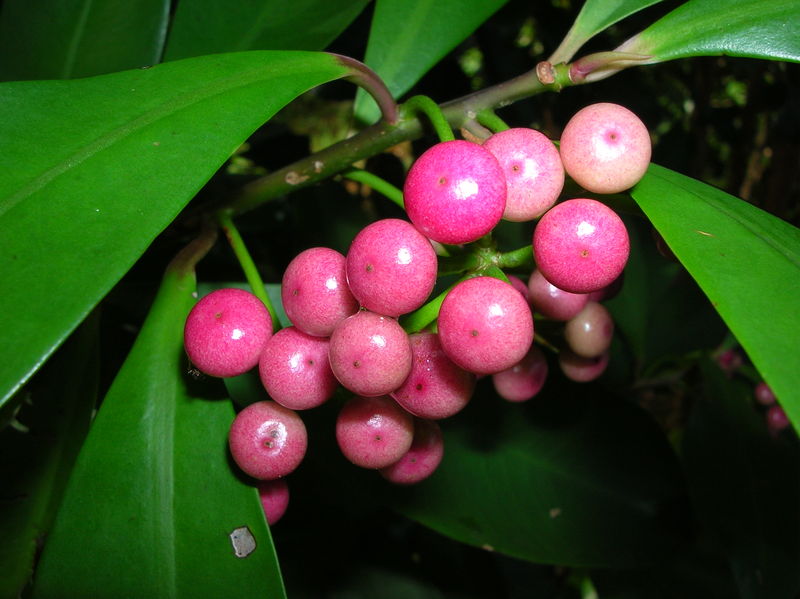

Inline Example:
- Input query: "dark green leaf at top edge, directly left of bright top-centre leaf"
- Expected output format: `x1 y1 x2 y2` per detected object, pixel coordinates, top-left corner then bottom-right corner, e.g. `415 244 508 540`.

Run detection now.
164 0 369 60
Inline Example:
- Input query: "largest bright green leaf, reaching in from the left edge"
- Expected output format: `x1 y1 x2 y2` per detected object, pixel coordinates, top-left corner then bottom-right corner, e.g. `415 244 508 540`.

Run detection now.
0 52 347 412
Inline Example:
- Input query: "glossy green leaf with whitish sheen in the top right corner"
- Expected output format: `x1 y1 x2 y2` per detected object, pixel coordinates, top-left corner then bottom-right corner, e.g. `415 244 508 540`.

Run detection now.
617 0 800 62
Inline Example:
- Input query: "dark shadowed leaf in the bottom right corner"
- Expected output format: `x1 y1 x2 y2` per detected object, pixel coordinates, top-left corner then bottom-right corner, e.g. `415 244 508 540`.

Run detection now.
683 360 800 599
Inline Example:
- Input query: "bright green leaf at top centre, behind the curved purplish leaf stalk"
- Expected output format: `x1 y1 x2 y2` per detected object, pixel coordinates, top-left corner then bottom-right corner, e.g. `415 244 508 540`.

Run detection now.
355 0 508 123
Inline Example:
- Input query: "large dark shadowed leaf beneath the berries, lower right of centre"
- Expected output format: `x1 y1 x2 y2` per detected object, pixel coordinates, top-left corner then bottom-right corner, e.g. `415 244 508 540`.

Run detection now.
389 384 682 567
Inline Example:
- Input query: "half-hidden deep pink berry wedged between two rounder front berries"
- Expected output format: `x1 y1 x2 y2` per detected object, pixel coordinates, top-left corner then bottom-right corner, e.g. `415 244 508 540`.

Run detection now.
391 333 475 420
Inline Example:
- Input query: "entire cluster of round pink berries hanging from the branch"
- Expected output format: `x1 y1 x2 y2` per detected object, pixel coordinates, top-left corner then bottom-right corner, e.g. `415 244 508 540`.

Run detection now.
185 104 650 522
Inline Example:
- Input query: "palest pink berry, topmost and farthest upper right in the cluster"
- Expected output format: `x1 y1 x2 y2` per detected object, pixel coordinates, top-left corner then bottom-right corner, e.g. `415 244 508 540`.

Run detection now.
560 102 652 193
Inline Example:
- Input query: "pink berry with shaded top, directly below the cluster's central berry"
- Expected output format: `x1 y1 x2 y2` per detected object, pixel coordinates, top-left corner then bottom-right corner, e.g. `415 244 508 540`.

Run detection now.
336 395 414 468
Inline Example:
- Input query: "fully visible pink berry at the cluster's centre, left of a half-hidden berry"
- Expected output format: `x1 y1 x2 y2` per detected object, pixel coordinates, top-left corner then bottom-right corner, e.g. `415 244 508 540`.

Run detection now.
328 310 411 397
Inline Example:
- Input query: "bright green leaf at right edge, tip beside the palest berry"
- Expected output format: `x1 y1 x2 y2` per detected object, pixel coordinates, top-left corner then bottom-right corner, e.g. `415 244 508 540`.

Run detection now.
631 164 800 430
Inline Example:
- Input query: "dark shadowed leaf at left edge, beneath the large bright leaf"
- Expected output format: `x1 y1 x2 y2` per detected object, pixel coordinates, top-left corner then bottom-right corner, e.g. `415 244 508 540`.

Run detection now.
0 314 99 597
